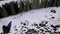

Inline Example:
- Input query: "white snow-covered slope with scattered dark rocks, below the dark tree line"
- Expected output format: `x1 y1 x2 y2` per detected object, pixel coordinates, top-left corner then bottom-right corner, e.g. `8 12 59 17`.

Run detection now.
0 7 60 34
